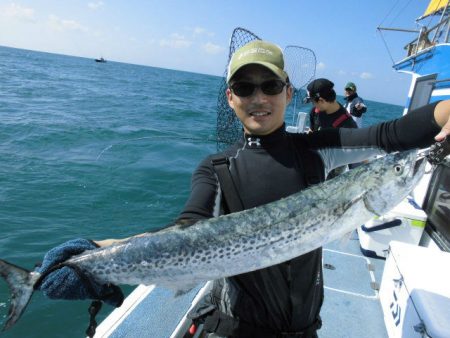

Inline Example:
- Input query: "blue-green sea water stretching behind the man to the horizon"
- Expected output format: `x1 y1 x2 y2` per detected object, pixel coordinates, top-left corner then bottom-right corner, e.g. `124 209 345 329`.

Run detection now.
0 47 402 338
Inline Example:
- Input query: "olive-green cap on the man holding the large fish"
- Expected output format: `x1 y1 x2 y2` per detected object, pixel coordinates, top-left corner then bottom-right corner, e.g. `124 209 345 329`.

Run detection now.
227 40 288 82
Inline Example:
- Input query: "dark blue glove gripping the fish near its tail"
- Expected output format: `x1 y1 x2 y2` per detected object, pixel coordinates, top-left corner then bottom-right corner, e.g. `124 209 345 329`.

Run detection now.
37 238 124 307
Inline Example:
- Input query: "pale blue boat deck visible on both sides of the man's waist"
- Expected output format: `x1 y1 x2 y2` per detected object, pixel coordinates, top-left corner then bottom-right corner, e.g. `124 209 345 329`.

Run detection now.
95 231 388 338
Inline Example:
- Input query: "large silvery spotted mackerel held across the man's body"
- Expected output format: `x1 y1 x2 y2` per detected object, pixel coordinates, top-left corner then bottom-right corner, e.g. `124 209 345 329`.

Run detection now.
0 151 425 329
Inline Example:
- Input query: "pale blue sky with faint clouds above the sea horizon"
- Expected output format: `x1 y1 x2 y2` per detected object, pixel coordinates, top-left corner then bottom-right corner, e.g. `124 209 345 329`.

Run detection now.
0 0 436 105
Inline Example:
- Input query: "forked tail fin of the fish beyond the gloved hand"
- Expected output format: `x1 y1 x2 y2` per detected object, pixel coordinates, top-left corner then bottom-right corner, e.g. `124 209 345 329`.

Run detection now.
0 259 40 331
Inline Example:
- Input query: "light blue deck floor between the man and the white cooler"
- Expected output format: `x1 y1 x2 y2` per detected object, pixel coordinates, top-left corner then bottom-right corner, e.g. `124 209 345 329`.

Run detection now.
319 231 388 338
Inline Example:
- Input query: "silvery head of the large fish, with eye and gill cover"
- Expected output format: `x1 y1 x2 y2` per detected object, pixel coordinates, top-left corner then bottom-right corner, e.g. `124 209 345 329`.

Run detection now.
362 150 426 216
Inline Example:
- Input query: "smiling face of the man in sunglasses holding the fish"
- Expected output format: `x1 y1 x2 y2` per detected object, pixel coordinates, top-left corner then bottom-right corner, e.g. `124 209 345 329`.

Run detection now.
226 65 292 135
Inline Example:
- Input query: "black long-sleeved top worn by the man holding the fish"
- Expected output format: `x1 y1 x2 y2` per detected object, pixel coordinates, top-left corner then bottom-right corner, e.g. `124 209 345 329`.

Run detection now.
179 104 440 336
